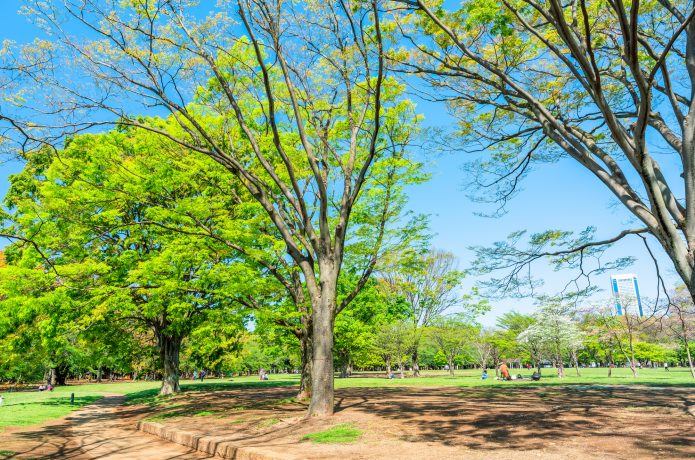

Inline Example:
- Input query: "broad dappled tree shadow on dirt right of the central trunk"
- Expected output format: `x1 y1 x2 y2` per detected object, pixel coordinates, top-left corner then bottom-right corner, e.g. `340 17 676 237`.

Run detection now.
337 386 695 457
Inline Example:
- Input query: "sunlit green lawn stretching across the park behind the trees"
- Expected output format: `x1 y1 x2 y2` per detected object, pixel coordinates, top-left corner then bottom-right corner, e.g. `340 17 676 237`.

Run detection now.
0 368 695 430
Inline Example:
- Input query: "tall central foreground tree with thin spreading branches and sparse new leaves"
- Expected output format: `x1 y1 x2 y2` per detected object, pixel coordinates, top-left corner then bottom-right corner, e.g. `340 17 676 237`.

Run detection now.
10 0 424 415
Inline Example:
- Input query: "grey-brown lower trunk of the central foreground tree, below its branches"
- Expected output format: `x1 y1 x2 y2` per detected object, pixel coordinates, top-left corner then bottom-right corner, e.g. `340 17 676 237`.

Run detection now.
309 280 337 417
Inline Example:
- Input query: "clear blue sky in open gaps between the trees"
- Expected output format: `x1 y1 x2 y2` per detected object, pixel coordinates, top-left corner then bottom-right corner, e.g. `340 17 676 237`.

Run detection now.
0 0 678 326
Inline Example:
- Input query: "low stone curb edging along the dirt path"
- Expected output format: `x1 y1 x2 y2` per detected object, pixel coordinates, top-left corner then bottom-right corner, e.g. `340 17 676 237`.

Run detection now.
137 420 295 460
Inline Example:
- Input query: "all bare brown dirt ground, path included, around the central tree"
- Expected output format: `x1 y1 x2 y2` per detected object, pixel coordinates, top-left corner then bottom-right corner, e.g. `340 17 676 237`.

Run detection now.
0 386 695 460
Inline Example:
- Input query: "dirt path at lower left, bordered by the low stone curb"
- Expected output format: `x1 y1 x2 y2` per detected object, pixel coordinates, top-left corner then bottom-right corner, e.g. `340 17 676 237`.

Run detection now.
0 395 208 460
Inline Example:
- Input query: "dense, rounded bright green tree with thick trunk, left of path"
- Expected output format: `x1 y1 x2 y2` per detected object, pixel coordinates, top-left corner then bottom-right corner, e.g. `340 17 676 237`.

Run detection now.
6 130 254 394
